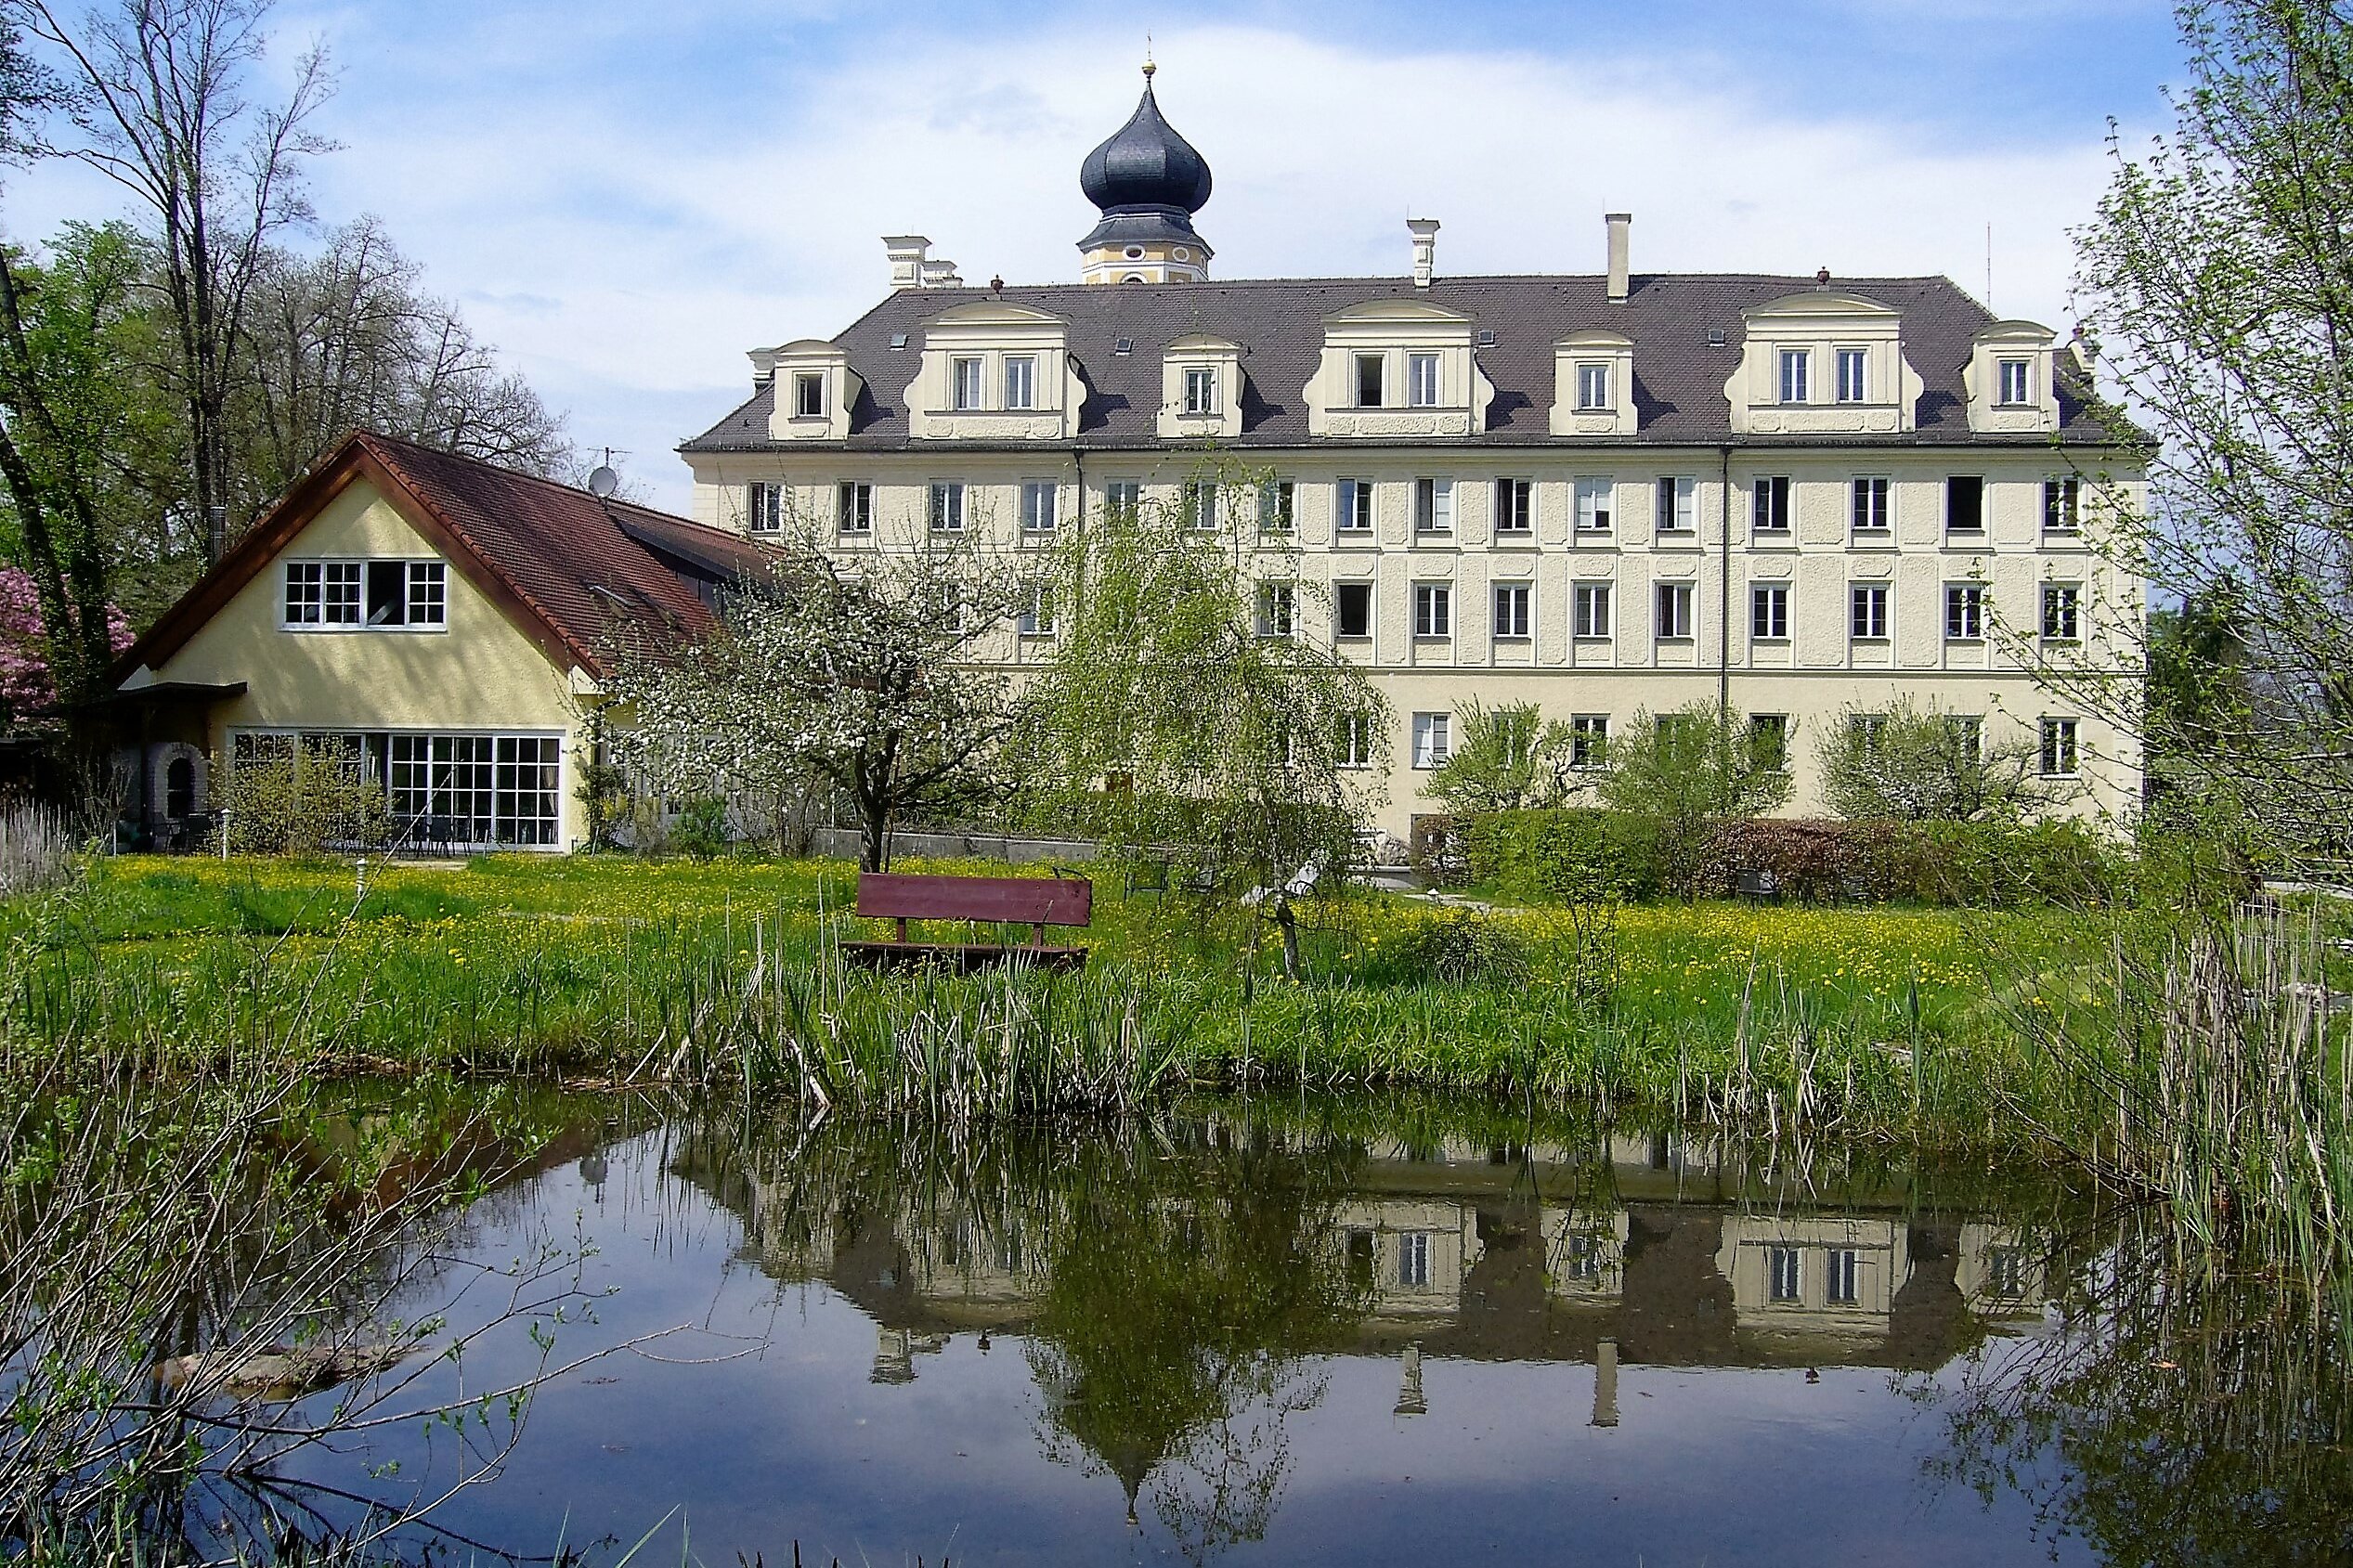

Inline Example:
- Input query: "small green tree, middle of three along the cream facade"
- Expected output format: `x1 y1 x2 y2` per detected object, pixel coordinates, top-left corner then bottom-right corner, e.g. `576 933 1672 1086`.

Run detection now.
1598 701 1790 898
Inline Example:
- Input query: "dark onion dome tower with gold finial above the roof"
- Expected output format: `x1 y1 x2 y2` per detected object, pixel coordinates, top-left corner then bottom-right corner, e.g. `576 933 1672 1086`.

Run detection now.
1078 63 1209 282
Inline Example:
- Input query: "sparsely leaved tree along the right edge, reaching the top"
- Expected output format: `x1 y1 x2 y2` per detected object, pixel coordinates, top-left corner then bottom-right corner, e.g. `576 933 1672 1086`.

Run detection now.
2071 0 2353 872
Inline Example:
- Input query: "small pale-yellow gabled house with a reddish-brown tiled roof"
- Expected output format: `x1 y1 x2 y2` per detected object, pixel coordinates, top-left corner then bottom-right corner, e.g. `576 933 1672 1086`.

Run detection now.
115 433 765 849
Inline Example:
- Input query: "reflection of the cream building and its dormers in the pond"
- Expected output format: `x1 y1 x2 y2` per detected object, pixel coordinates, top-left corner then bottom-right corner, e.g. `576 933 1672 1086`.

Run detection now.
680 1135 2045 1404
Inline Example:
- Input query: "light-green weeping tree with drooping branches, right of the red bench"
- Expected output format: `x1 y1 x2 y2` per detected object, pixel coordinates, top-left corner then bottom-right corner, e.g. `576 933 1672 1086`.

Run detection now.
1012 463 1388 978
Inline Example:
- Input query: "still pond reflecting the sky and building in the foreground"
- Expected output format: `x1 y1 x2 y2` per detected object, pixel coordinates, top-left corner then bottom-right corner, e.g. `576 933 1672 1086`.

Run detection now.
229 1103 2353 1565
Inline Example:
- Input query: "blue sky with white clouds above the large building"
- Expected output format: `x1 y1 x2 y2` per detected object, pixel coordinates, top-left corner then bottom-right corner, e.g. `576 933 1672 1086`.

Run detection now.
0 0 2178 505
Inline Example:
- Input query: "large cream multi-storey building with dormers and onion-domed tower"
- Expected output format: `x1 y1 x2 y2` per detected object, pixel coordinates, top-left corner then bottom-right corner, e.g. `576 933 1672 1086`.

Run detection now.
682 67 2141 832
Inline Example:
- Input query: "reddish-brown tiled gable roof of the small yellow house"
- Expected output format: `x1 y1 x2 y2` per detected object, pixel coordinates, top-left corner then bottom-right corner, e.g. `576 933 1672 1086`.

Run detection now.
123 433 765 675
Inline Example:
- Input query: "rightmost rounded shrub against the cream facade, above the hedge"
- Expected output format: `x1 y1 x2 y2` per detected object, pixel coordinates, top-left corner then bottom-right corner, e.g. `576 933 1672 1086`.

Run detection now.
1819 698 2049 823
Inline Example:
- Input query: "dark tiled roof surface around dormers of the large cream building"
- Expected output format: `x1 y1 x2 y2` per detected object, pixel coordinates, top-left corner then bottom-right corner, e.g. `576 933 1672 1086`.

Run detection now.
680 273 2106 451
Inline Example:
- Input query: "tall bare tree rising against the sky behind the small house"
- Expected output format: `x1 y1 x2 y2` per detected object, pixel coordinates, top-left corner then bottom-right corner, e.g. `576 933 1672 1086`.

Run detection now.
12 0 332 552
